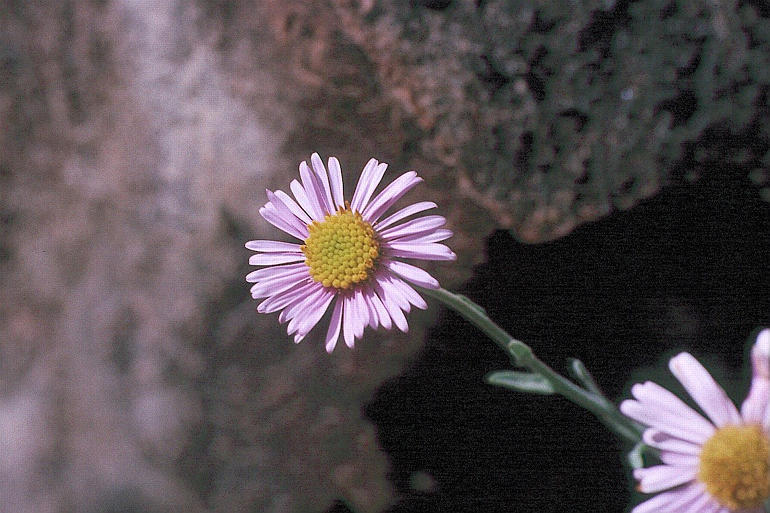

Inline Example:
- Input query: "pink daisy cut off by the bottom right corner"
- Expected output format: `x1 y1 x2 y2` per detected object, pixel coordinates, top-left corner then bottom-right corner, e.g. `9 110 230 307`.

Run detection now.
620 329 770 513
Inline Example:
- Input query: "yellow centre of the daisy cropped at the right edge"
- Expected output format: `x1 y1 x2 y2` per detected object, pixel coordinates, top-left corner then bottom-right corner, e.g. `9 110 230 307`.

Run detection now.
698 425 770 511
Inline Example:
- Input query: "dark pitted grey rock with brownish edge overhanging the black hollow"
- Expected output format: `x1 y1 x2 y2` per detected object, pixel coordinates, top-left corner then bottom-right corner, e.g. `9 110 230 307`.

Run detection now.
274 0 770 242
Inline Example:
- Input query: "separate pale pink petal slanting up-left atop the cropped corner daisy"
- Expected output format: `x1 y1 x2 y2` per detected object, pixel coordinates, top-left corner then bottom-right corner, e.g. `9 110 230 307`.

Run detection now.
668 353 741 427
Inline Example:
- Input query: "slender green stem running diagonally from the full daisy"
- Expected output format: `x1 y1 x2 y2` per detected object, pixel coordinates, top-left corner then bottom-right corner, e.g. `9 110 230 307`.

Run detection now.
421 288 643 444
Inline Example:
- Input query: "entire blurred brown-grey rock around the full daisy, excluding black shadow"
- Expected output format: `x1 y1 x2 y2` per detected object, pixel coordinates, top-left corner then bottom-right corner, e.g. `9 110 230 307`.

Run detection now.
0 0 770 513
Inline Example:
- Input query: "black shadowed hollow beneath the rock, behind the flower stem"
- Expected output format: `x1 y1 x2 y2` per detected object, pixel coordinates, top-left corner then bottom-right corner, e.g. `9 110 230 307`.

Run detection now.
366 166 770 513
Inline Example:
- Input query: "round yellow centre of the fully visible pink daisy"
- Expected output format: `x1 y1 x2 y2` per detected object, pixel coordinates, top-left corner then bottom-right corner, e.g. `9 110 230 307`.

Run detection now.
302 208 380 289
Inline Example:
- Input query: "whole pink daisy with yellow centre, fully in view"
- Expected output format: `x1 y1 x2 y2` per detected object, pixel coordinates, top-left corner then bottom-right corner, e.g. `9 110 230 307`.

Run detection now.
246 153 455 353
